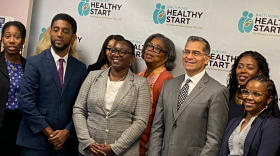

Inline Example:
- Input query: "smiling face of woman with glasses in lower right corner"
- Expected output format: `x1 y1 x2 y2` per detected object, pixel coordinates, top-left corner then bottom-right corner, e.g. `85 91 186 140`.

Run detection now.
242 80 272 116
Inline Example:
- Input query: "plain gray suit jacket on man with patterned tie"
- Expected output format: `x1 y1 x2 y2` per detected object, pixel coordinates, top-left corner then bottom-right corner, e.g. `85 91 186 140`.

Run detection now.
148 73 228 156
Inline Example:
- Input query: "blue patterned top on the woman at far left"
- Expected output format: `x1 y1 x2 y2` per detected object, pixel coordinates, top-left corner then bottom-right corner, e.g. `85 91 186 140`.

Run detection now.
5 58 23 110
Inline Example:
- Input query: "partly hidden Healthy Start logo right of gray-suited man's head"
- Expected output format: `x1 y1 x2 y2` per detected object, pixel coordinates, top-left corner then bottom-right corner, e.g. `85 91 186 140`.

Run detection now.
206 50 237 72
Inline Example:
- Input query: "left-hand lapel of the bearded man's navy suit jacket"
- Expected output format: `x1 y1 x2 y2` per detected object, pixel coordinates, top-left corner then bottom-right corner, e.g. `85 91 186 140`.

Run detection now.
46 49 61 94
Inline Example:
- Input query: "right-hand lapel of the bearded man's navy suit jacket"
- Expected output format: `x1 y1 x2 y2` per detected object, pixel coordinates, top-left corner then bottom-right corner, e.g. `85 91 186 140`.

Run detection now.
61 54 75 95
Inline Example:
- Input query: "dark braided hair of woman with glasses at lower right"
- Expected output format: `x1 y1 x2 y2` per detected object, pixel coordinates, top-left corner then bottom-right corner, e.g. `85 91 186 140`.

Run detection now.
245 75 278 118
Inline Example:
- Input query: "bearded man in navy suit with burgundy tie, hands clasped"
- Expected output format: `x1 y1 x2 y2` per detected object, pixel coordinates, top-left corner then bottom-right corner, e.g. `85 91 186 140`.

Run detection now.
16 14 86 156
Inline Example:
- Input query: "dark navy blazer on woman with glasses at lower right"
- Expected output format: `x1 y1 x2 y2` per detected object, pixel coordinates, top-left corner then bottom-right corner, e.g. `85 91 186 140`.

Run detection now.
218 116 280 156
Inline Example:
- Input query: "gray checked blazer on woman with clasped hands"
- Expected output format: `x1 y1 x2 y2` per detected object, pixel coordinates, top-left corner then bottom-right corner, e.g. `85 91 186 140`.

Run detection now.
73 68 151 156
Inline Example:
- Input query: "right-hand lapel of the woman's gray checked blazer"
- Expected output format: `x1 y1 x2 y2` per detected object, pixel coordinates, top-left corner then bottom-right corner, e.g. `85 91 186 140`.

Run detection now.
110 70 134 112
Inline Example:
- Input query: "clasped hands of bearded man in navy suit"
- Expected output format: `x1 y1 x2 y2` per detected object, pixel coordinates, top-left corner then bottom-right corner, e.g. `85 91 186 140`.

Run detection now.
48 129 70 150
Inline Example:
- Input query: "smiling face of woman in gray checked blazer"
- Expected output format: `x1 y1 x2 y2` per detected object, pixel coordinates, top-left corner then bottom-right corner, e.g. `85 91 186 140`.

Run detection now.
111 41 135 71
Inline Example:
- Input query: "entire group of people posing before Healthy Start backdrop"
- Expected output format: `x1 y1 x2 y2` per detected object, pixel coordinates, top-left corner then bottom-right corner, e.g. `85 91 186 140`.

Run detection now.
0 14 280 156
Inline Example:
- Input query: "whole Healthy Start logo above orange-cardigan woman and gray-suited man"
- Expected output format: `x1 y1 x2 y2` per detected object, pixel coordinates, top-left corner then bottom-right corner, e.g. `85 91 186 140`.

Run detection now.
153 3 203 29
